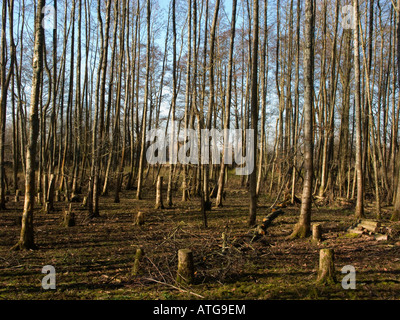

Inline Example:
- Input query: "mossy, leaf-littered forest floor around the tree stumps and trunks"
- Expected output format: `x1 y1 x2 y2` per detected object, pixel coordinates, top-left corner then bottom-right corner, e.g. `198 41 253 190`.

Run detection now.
0 175 400 300
